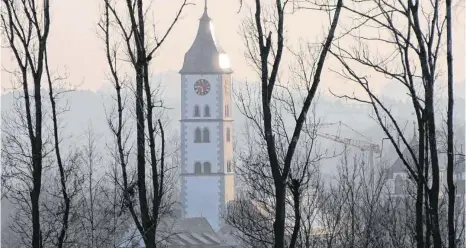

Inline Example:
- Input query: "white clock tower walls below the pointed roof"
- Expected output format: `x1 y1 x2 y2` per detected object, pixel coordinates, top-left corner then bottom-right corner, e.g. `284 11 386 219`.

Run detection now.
181 72 234 230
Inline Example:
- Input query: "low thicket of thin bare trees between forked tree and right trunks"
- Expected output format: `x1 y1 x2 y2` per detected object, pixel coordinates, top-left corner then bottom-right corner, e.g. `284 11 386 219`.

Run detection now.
315 151 428 248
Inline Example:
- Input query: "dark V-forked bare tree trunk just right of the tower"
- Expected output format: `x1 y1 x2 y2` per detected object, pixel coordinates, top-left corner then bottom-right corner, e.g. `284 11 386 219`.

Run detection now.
244 0 343 245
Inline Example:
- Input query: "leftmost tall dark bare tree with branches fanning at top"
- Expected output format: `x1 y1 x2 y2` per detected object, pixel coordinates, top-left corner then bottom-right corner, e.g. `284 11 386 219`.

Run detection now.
1 0 50 248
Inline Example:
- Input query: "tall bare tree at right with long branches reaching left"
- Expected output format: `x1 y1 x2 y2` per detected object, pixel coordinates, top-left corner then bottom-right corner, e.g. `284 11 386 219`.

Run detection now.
330 0 453 244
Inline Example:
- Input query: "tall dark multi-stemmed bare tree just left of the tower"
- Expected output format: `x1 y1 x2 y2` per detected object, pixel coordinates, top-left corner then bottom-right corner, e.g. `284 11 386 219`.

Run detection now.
99 0 187 248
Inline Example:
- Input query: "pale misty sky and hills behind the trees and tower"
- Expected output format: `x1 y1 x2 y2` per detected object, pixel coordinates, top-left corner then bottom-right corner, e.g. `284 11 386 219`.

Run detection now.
1 0 465 244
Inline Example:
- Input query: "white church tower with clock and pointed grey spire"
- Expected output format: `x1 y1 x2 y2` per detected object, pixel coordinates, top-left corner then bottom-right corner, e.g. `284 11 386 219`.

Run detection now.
180 0 235 230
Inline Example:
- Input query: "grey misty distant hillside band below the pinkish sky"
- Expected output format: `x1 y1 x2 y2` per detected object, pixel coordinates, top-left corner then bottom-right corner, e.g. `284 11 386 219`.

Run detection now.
1 71 465 170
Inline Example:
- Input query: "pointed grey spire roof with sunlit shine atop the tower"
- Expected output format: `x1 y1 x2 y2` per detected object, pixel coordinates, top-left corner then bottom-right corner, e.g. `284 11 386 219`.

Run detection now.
180 0 232 74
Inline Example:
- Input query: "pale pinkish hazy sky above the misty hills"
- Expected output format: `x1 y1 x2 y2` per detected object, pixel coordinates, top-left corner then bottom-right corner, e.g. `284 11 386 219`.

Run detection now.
1 0 465 94
